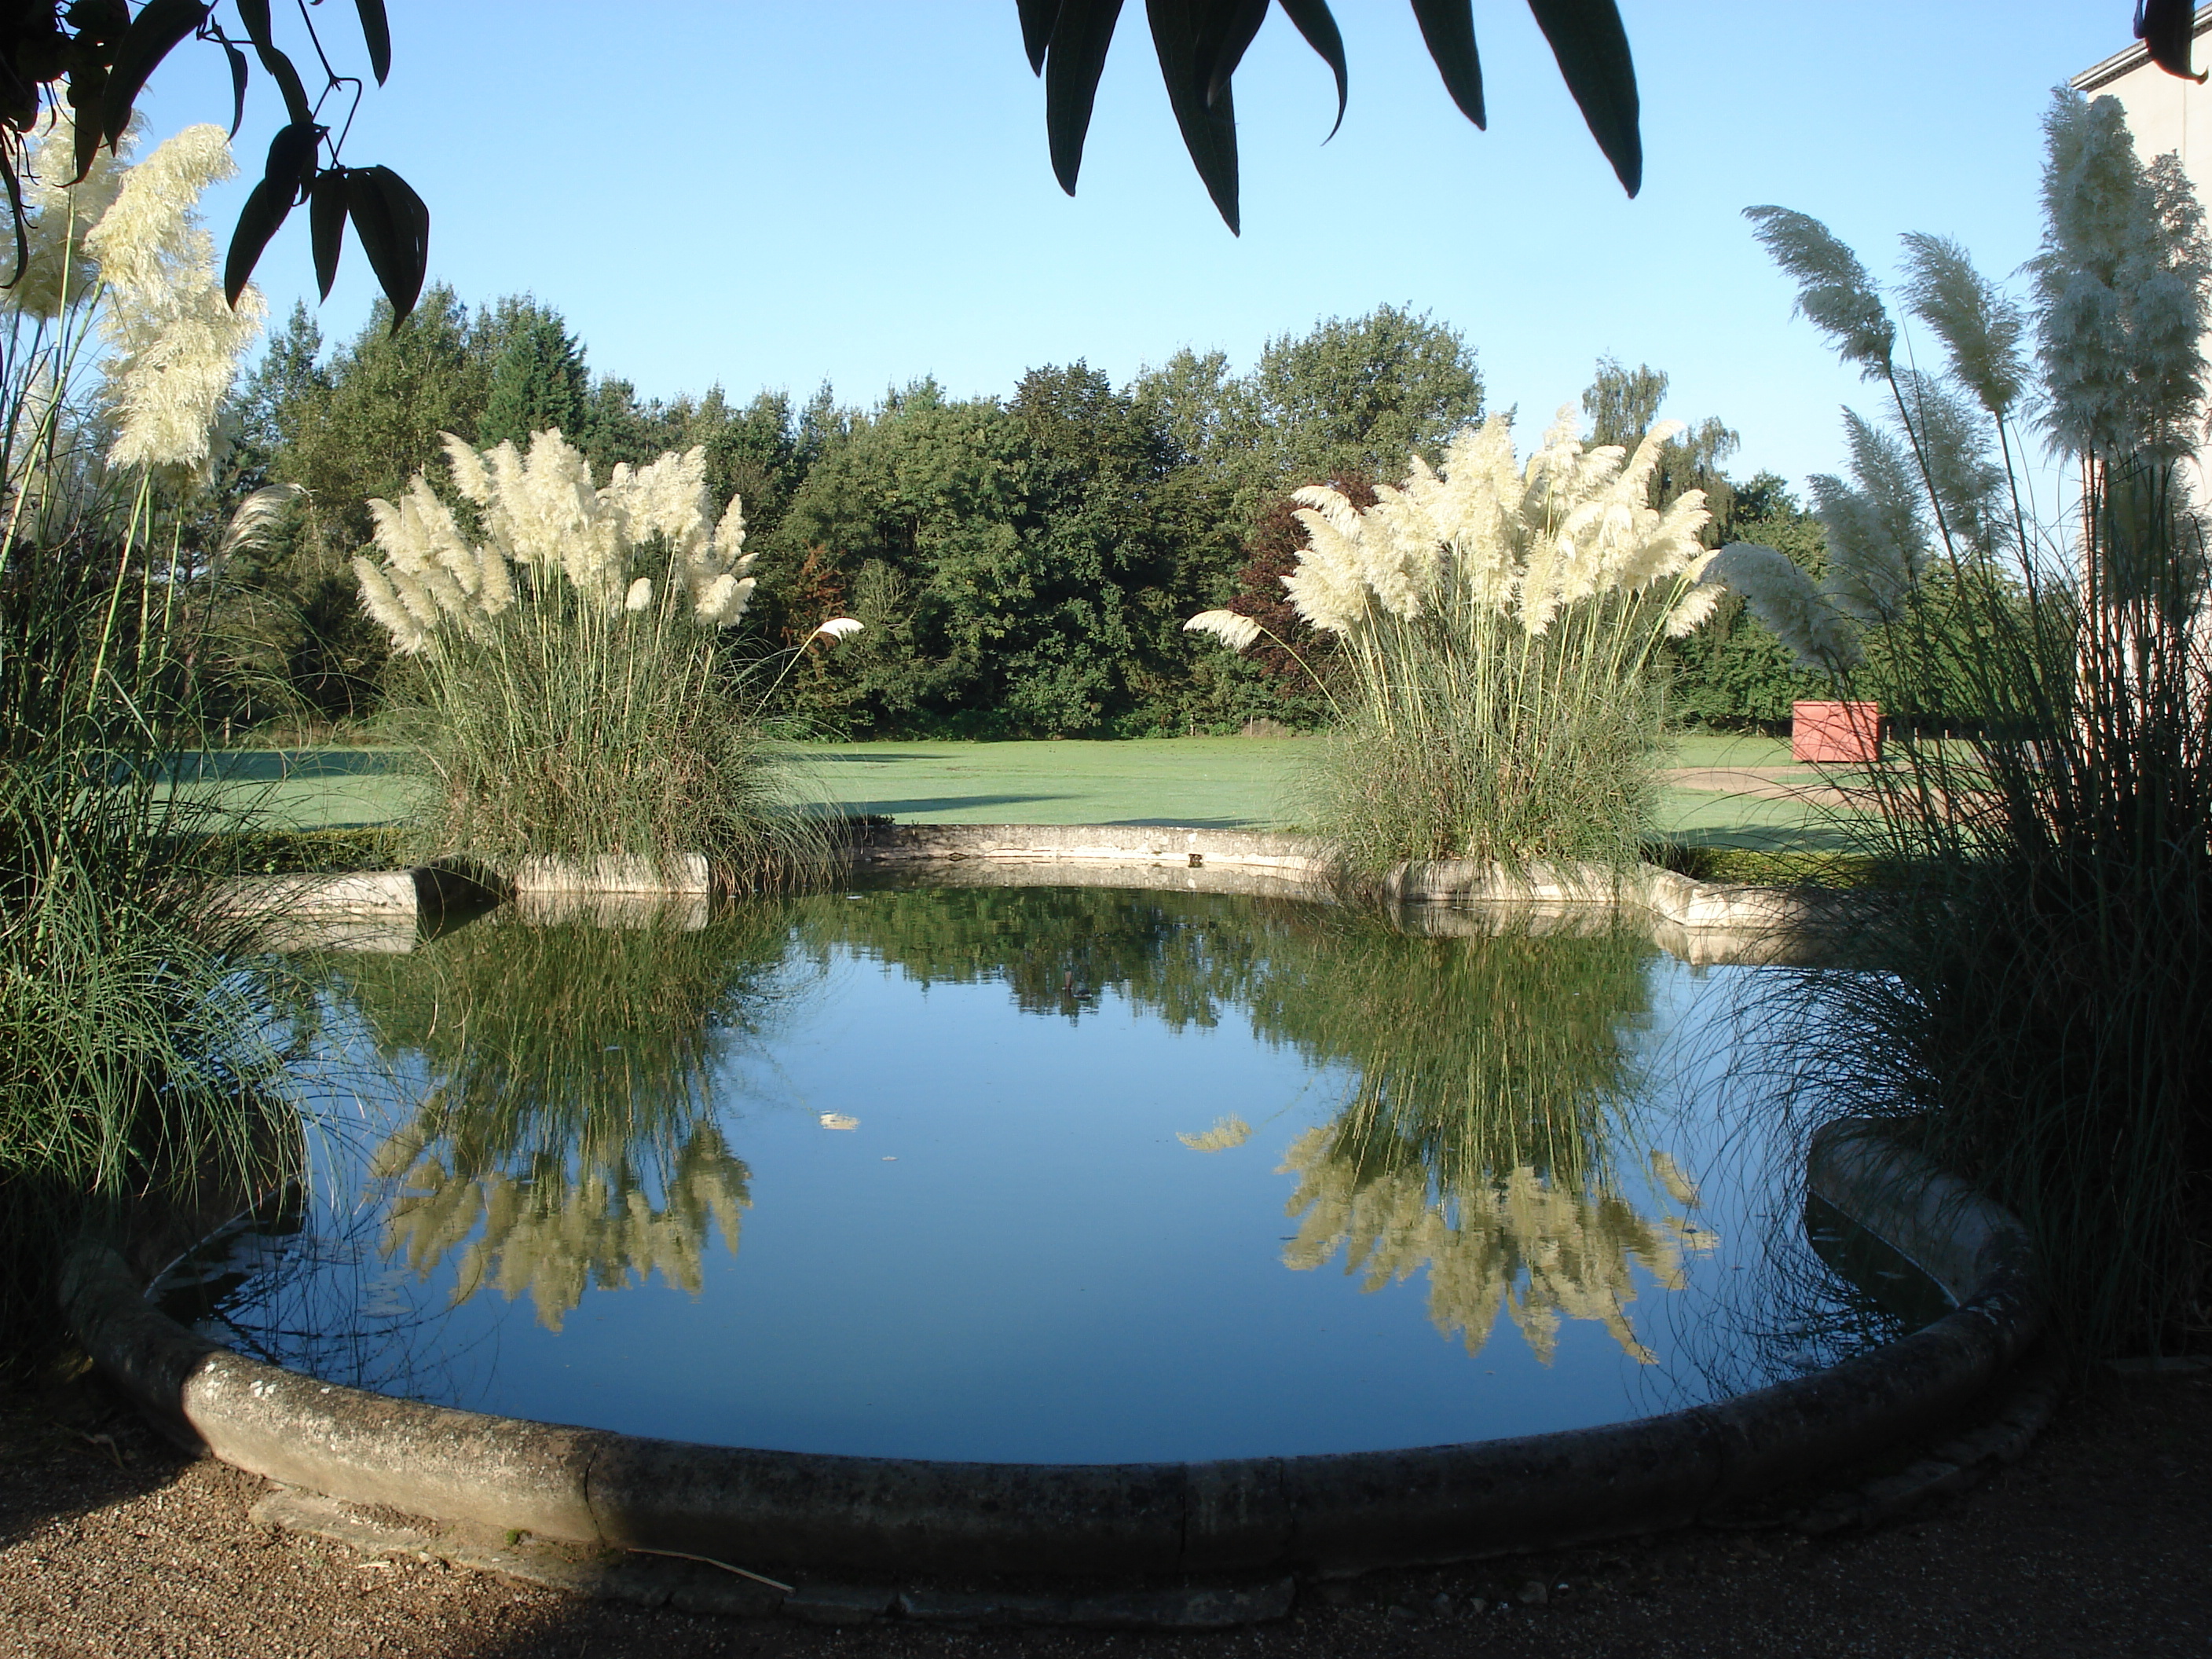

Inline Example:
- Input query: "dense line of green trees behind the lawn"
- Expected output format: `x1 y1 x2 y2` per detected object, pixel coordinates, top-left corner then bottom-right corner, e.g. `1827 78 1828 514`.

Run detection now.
203 296 1825 737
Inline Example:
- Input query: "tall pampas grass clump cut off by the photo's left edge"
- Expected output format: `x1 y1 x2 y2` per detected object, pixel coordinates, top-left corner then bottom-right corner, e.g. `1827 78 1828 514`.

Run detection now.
0 113 296 1369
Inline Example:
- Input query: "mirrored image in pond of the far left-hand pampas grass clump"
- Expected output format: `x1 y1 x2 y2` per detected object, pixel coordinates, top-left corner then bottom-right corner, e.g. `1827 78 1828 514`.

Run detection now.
307 909 786 1329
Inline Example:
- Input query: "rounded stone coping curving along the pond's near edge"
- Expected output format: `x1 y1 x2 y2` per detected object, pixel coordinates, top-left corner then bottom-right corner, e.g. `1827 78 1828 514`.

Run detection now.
62 1122 2042 1577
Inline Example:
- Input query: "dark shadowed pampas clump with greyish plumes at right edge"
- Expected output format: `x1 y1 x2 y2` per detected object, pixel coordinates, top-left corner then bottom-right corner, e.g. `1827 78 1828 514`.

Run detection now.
1714 93 2212 1358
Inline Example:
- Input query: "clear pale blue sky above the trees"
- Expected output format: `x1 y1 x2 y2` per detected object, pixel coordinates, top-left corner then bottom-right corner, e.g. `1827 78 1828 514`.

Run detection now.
148 0 2133 493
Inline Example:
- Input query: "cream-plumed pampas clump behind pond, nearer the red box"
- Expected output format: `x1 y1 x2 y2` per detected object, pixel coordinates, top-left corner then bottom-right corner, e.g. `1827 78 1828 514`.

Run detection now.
1185 409 1716 881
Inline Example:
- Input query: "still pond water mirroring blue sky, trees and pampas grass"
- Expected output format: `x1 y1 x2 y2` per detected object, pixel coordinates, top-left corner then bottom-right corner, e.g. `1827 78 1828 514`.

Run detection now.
163 883 1933 1462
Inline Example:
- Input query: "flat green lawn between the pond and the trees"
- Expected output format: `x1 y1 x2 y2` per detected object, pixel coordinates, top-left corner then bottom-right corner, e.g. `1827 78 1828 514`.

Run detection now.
201 734 1843 848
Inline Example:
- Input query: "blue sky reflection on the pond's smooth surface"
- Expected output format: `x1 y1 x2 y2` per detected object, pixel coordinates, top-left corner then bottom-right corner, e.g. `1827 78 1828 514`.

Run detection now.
190 911 1911 1462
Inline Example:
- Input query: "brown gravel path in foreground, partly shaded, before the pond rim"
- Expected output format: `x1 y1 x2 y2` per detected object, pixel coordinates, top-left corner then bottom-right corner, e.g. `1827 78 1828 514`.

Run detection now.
0 1374 2212 1659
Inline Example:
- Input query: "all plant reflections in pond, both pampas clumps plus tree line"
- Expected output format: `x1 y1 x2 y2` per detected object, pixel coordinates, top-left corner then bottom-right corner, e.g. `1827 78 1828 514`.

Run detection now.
302 889 1714 1363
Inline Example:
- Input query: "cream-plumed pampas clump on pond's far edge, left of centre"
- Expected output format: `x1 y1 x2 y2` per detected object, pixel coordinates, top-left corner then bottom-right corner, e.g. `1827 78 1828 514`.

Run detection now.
354 431 860 883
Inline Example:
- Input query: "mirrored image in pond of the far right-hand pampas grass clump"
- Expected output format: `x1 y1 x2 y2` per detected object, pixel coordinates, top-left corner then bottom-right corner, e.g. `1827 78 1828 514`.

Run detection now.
1254 929 1712 1363
